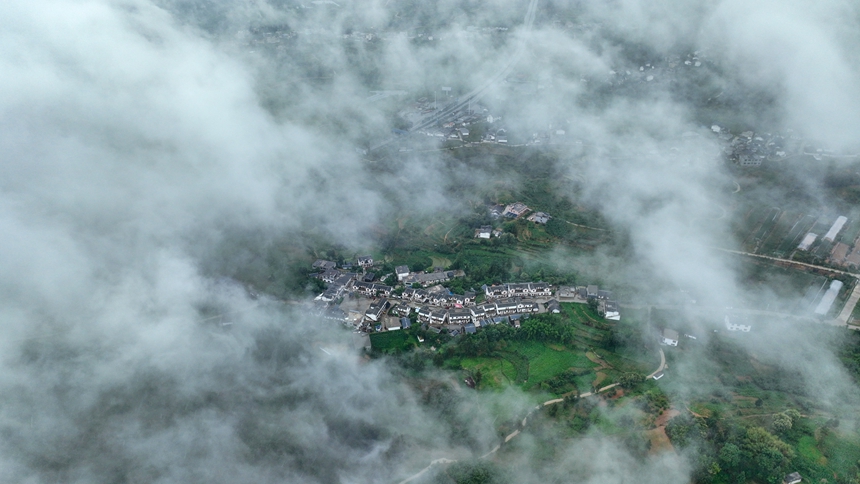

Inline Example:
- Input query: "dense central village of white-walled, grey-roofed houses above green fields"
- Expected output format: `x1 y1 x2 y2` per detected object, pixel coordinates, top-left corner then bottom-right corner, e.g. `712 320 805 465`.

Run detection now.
312 251 621 336
